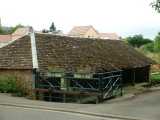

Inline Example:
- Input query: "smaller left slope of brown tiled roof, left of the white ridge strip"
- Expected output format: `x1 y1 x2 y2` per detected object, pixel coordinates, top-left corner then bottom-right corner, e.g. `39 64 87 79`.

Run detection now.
0 36 32 69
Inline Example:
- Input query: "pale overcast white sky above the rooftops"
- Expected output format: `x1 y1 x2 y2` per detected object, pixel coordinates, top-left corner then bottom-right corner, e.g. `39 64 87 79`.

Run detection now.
0 0 160 39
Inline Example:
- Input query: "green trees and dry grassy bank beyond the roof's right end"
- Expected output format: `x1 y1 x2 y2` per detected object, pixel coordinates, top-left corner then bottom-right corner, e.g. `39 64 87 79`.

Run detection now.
125 33 160 84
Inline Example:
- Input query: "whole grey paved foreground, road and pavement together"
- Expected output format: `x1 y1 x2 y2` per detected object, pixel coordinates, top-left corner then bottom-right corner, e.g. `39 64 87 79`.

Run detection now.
0 90 160 120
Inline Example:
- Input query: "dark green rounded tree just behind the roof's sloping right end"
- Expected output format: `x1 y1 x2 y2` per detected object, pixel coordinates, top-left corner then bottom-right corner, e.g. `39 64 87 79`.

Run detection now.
126 35 152 48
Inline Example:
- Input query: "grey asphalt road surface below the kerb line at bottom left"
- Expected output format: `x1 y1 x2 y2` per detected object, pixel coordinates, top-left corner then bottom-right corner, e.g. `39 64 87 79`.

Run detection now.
0 105 117 120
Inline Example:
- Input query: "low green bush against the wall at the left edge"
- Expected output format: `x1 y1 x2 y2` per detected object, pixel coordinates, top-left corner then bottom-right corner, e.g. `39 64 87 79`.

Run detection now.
0 76 24 96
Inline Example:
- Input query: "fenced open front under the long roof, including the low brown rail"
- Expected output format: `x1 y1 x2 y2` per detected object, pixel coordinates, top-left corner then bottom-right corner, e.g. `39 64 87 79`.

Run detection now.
35 71 122 103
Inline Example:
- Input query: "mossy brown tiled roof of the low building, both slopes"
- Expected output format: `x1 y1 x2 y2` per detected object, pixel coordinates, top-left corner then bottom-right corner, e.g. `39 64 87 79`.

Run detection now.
0 34 152 72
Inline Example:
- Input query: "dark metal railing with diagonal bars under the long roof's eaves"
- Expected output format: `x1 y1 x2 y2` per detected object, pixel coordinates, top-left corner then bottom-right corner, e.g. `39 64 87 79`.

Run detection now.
35 71 122 101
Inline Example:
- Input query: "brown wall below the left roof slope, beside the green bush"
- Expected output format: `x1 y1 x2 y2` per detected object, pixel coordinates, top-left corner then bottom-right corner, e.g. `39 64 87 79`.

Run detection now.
0 70 33 96
